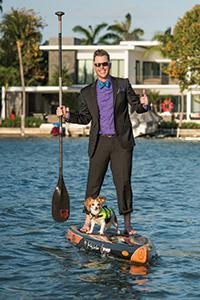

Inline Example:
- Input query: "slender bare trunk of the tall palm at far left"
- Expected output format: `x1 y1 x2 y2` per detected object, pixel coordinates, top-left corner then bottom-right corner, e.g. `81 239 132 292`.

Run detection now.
16 41 26 136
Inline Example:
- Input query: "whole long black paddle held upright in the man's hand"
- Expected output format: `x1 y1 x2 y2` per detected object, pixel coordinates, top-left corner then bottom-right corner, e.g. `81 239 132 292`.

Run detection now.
52 11 70 222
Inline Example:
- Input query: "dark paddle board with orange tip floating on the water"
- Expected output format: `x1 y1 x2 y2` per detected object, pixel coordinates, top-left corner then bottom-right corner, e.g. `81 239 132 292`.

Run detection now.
66 226 157 265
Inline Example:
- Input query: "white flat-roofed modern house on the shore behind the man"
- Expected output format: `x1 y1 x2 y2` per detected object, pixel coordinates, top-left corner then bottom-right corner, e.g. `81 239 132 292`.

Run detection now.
2 38 200 122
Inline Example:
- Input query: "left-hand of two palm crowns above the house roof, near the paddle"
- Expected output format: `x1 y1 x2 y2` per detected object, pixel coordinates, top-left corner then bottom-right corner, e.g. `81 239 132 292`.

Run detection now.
73 23 113 45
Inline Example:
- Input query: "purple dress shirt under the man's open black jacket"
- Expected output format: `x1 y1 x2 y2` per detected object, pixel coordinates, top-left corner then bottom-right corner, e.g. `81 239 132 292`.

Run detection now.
96 79 115 135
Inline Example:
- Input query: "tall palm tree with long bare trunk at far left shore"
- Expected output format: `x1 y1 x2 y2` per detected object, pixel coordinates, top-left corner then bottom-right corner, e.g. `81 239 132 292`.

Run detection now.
0 8 44 135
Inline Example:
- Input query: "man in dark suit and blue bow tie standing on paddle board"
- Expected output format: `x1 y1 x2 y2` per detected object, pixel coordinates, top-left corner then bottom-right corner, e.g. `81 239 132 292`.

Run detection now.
57 49 148 235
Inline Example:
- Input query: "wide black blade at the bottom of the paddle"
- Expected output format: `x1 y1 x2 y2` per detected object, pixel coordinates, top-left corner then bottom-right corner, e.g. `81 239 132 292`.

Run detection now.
52 176 70 222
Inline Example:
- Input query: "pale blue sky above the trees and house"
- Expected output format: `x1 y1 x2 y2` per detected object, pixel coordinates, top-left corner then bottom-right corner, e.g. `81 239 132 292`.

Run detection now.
0 0 200 42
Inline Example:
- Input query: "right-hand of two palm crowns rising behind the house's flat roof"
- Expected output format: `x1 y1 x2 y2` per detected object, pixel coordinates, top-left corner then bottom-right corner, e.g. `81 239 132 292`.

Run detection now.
108 13 144 44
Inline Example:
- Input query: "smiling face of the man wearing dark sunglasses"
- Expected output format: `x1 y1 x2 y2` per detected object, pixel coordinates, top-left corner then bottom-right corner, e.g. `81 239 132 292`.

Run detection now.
94 55 110 81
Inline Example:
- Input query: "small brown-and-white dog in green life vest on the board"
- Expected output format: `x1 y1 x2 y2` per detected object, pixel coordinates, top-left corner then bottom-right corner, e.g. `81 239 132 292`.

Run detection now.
84 197 120 235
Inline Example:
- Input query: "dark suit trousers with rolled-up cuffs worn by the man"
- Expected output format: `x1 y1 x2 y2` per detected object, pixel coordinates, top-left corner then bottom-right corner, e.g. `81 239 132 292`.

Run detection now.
86 135 133 214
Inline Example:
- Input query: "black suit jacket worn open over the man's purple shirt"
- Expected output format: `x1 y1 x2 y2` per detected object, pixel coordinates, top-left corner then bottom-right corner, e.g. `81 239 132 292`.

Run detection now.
68 76 147 157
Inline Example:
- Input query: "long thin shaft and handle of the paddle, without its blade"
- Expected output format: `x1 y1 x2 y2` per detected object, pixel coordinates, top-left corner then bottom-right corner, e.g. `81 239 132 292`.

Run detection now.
56 11 64 177
